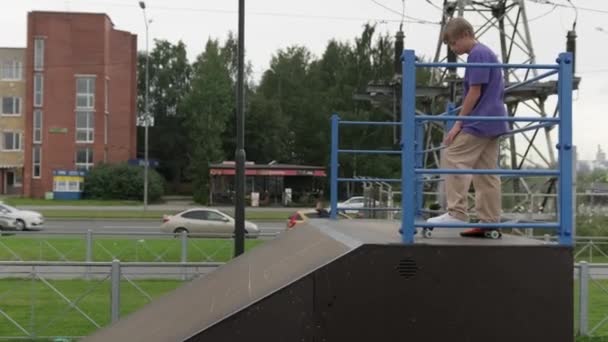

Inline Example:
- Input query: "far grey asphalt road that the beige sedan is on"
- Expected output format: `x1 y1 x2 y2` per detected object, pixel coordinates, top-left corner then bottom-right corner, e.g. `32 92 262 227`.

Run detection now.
26 219 285 234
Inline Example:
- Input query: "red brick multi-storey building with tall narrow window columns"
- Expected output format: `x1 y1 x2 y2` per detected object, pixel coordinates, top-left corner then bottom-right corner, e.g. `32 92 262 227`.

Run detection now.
23 12 137 197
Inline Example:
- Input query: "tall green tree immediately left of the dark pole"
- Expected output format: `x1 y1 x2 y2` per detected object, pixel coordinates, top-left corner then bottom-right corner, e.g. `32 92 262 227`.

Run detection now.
182 39 234 203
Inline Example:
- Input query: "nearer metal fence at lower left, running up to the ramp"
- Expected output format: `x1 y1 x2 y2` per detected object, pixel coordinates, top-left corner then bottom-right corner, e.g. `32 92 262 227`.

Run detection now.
0 260 222 340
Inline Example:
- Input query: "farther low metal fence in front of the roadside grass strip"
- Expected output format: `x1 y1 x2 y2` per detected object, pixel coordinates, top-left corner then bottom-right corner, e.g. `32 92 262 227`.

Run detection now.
0 230 277 263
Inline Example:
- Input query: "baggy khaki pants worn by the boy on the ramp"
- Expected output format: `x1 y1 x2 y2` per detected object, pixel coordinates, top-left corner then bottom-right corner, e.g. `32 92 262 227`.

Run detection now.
441 132 502 222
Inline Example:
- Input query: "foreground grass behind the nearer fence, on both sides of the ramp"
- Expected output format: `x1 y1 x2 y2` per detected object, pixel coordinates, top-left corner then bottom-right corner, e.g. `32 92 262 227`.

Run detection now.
0 279 608 342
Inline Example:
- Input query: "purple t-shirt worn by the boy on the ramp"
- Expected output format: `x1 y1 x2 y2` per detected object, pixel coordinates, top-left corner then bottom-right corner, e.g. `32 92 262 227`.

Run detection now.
462 43 509 137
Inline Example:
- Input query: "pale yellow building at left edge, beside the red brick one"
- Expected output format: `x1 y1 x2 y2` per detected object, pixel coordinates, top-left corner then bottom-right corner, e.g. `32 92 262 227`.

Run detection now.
0 48 25 195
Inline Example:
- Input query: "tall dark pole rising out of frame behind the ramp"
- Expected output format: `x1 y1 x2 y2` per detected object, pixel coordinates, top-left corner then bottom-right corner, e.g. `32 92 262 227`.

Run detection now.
234 0 246 256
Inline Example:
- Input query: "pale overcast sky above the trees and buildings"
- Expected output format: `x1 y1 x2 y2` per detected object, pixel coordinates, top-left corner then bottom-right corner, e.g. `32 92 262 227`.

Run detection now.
0 0 608 159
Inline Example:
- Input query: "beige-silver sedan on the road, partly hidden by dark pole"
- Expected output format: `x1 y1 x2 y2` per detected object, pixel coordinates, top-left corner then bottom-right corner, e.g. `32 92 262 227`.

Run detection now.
160 208 260 237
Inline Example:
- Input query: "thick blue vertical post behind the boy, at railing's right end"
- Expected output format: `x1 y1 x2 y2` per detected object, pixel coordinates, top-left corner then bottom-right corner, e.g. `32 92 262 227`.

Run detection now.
557 53 574 245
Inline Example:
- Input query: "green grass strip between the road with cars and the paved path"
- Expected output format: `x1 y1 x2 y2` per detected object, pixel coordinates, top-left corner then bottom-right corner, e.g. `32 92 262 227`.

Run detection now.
0 236 264 262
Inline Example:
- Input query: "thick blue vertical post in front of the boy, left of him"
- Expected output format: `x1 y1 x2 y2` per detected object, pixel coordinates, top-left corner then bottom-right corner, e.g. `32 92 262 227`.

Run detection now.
401 50 416 244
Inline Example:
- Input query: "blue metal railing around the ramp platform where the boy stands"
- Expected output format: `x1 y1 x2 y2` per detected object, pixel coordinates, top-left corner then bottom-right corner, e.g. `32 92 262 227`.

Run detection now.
330 50 574 245
